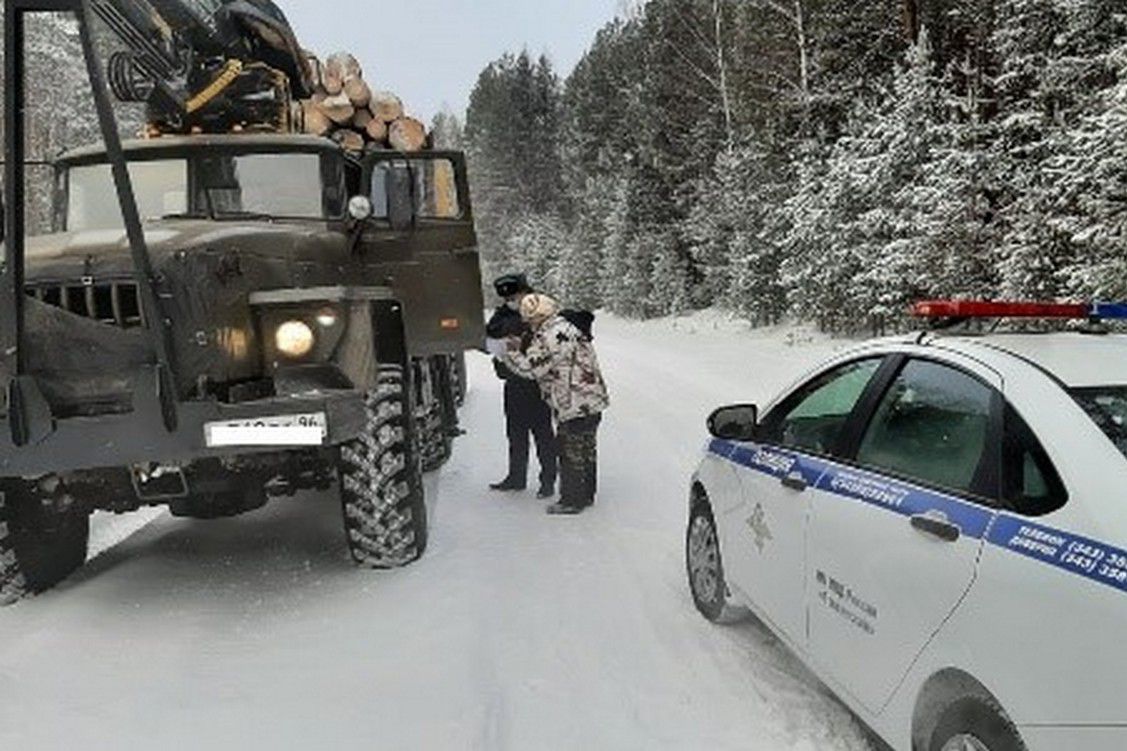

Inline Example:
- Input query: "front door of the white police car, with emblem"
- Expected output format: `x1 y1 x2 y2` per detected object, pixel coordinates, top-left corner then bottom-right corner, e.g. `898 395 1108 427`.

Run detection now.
721 357 881 647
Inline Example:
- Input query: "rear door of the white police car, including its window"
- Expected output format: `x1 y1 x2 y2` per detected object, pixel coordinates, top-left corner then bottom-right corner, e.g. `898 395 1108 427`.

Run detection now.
807 356 1002 712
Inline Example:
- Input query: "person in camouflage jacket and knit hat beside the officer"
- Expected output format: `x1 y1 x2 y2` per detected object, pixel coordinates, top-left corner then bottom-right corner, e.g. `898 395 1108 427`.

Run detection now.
503 294 610 514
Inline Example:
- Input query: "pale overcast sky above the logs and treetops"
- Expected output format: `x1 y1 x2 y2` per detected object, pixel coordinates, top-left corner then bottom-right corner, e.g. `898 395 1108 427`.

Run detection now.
275 0 621 123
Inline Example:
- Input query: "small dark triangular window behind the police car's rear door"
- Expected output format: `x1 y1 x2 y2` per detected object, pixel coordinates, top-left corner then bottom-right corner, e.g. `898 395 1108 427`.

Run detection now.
1002 405 1068 516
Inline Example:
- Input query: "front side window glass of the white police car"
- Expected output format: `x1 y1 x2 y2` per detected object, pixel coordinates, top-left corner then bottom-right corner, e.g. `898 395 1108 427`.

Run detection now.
764 357 881 453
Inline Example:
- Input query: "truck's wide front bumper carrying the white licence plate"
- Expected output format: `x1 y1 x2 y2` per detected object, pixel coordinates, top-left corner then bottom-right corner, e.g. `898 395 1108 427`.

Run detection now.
0 370 365 477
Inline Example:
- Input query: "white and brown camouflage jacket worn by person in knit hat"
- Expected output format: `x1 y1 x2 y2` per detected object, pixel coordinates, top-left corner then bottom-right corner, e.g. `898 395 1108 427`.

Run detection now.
504 316 610 423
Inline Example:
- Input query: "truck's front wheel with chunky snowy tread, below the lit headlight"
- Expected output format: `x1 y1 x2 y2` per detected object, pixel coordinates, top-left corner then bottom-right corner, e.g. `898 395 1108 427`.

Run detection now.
337 365 427 568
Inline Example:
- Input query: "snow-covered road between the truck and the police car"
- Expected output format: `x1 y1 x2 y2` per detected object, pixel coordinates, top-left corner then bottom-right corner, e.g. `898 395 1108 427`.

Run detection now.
0 308 868 751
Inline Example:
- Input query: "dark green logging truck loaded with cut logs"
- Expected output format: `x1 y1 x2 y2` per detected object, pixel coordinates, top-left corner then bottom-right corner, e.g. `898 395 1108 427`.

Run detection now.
0 0 485 603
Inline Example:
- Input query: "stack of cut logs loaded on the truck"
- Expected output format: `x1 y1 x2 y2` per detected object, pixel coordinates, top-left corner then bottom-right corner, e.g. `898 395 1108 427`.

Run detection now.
298 52 429 151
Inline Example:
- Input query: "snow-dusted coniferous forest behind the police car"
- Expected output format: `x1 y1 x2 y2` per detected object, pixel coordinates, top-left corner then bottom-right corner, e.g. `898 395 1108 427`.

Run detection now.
457 0 1127 330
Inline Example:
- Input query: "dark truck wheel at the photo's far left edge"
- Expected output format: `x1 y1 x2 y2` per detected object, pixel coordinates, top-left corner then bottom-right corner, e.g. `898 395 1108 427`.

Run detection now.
0 480 90 604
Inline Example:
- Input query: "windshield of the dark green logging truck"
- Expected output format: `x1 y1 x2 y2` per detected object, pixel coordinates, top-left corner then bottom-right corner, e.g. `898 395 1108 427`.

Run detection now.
66 147 326 226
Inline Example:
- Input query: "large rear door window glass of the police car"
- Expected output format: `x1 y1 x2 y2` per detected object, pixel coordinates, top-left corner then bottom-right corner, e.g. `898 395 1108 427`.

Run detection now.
857 360 997 497
